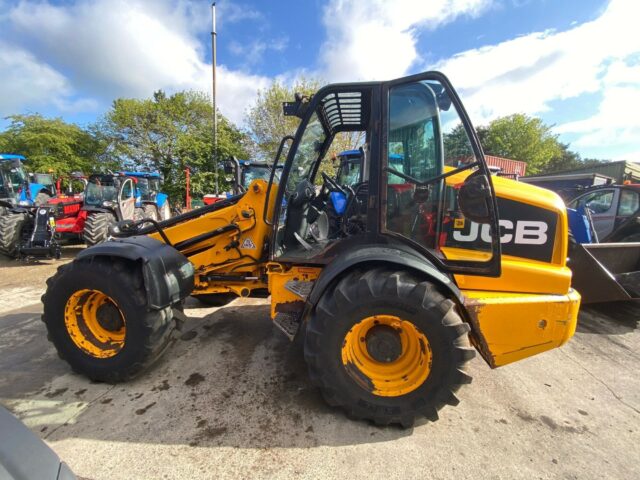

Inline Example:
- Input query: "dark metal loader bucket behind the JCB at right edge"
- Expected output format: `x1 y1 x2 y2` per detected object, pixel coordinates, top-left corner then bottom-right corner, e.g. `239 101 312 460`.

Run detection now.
569 242 640 304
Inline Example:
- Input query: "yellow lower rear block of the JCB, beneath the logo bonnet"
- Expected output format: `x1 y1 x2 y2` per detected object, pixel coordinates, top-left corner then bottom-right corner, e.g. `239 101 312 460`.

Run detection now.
463 290 580 368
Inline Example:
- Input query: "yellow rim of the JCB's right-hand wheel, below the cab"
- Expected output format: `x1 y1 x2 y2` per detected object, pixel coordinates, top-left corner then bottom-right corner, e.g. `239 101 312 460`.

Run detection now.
342 315 432 397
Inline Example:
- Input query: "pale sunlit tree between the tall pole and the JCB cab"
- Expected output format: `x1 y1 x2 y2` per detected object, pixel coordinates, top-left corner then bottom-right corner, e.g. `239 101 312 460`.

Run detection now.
246 77 320 162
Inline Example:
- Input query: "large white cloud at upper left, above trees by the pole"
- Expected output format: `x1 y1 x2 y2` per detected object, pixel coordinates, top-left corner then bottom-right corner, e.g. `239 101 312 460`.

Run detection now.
0 0 269 122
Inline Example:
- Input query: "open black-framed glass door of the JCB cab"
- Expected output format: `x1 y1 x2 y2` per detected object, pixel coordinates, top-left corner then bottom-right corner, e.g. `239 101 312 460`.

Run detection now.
380 72 501 276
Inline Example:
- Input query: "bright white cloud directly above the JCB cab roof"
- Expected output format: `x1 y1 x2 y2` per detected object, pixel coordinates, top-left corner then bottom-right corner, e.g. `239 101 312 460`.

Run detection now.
320 0 491 81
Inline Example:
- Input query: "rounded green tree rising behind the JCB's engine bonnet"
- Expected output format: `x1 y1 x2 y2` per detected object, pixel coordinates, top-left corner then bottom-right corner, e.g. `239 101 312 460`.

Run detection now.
482 113 562 174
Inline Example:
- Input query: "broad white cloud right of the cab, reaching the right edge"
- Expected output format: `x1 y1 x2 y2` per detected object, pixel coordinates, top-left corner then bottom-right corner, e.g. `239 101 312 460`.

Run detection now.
430 0 640 145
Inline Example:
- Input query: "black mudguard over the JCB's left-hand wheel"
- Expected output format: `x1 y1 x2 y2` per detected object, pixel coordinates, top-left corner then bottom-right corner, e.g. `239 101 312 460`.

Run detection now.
76 236 194 310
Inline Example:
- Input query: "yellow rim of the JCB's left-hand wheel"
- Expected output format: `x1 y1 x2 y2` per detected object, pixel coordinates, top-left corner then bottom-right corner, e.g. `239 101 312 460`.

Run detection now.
64 290 126 358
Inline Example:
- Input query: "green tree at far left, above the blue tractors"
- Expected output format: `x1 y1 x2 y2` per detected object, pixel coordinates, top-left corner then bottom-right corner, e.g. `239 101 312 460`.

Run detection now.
0 114 107 175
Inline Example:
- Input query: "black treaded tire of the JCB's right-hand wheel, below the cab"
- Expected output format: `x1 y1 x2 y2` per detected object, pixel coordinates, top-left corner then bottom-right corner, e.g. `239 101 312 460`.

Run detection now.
304 268 475 428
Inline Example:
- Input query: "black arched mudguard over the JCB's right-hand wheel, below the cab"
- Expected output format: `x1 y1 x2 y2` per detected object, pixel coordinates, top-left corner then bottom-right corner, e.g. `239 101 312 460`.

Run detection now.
303 245 464 312
